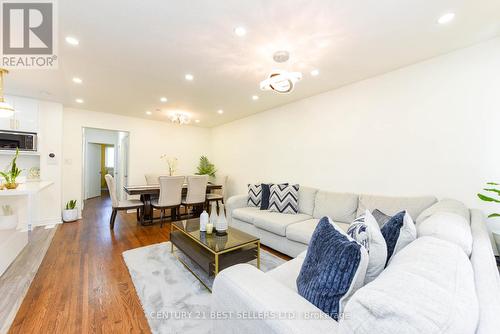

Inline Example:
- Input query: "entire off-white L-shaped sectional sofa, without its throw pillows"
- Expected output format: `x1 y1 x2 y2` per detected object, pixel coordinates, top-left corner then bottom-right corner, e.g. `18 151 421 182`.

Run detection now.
212 188 500 334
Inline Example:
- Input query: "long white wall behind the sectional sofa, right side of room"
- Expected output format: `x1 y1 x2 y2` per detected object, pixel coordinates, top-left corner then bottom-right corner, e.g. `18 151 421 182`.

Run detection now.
212 38 500 214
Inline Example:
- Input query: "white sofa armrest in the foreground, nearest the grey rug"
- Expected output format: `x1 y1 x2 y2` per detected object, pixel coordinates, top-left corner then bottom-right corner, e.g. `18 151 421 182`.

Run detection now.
212 264 338 334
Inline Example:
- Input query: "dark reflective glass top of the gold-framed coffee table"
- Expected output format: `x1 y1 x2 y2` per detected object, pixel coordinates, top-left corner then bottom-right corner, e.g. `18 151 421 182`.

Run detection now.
172 218 259 253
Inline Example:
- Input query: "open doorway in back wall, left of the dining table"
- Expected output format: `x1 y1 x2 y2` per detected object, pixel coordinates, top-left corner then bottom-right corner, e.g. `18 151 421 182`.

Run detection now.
82 128 129 200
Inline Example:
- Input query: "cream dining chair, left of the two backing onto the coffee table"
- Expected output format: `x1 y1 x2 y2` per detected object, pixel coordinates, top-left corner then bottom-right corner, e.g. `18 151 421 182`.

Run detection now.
151 176 184 227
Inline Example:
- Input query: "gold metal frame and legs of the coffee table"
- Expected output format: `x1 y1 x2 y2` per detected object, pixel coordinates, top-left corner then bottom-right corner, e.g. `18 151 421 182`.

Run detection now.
170 222 260 291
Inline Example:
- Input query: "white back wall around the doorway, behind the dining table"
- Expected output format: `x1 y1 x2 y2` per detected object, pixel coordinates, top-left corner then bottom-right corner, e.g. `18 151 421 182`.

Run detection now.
63 108 210 211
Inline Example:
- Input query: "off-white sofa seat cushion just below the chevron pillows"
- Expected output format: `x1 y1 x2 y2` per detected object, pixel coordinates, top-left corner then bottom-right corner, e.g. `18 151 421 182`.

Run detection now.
252 211 312 237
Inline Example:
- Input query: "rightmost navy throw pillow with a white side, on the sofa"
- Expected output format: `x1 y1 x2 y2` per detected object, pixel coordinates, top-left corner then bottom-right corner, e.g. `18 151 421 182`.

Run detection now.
380 211 417 266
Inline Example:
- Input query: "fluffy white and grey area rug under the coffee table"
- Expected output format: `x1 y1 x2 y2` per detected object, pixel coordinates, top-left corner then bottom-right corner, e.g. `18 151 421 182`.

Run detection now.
123 242 285 334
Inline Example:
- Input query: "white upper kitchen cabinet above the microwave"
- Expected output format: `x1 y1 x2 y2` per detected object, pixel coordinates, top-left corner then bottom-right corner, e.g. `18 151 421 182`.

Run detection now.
0 96 38 132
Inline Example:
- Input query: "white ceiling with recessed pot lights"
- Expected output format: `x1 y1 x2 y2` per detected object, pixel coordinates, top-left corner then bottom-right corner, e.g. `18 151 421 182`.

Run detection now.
6 0 500 127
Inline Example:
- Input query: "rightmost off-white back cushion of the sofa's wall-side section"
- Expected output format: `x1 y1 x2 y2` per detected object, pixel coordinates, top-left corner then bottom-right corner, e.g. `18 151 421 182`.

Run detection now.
356 195 437 218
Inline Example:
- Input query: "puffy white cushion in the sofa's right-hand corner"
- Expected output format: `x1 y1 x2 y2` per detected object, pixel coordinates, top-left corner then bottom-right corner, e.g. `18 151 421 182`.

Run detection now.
417 212 472 256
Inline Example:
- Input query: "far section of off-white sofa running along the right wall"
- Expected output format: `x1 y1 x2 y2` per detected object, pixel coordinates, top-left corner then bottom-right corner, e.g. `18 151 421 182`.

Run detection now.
226 187 437 257
